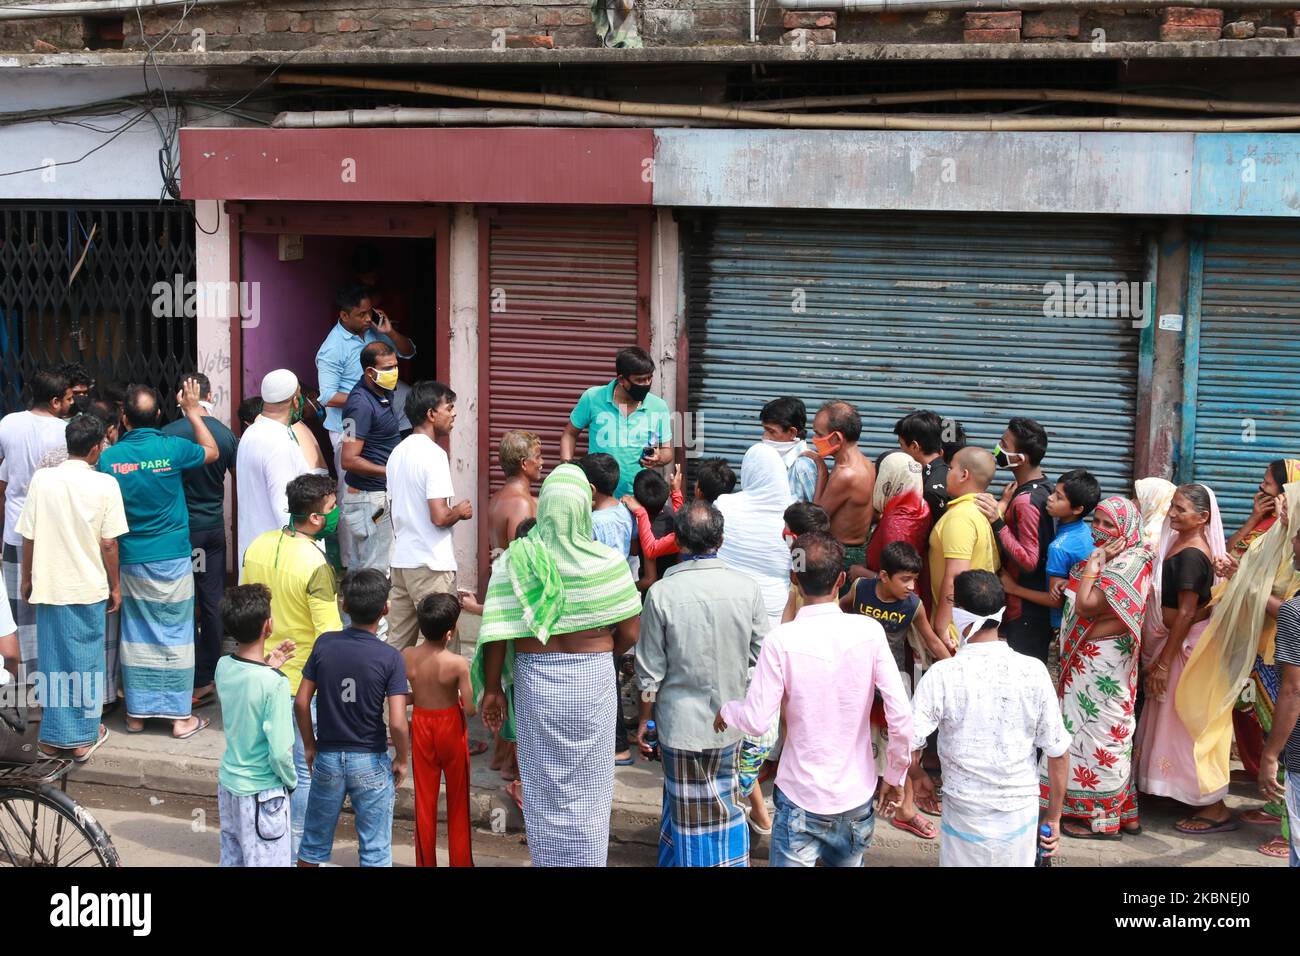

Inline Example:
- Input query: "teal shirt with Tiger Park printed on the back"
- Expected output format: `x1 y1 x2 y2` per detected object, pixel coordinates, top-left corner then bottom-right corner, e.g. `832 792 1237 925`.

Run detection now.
99 428 204 564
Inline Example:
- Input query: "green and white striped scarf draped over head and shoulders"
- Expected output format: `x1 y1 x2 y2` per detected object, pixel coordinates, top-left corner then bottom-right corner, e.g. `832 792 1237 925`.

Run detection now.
472 464 641 740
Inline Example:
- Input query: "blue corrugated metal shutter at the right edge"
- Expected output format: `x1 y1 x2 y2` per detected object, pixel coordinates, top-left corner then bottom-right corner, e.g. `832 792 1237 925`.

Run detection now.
1179 222 1300 533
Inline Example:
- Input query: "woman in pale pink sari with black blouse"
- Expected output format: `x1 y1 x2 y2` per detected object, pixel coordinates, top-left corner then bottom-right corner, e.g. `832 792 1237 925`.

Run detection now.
1136 484 1239 834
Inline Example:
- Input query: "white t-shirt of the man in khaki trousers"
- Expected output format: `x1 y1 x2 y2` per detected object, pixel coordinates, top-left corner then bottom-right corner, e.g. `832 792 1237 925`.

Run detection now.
387 434 456 571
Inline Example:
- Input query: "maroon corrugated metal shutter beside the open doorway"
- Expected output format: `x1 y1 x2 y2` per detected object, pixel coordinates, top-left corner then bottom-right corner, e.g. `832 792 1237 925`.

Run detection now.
481 212 649 494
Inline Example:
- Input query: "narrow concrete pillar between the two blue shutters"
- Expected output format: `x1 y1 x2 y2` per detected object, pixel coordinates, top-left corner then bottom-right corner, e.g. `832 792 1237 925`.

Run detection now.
1134 219 1191 480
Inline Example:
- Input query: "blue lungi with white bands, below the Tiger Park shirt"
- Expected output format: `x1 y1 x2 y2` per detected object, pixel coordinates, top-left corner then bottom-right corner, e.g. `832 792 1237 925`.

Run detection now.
121 557 194 721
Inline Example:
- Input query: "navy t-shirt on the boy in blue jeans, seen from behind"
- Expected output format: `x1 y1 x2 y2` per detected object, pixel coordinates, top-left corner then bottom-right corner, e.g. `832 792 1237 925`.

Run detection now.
303 627 411 753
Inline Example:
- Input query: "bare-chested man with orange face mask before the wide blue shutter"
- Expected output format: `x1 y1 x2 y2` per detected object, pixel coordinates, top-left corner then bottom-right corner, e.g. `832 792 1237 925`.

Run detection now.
803 402 876 587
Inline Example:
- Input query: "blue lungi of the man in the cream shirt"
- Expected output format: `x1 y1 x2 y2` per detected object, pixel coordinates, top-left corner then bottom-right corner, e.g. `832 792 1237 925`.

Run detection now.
35 601 108 749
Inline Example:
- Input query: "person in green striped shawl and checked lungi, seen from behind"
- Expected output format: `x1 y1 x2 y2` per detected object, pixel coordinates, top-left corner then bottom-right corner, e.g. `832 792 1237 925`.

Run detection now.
473 464 641 866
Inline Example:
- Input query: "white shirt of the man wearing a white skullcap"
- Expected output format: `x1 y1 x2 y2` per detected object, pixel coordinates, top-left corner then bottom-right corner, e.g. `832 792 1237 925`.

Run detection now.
235 415 307 566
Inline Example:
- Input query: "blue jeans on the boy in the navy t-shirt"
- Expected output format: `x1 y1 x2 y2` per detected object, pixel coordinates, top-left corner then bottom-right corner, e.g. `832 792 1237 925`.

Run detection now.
298 750 397 866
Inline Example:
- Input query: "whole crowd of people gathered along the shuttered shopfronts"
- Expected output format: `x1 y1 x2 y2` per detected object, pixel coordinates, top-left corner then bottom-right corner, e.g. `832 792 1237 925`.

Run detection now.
0 297 1300 866
